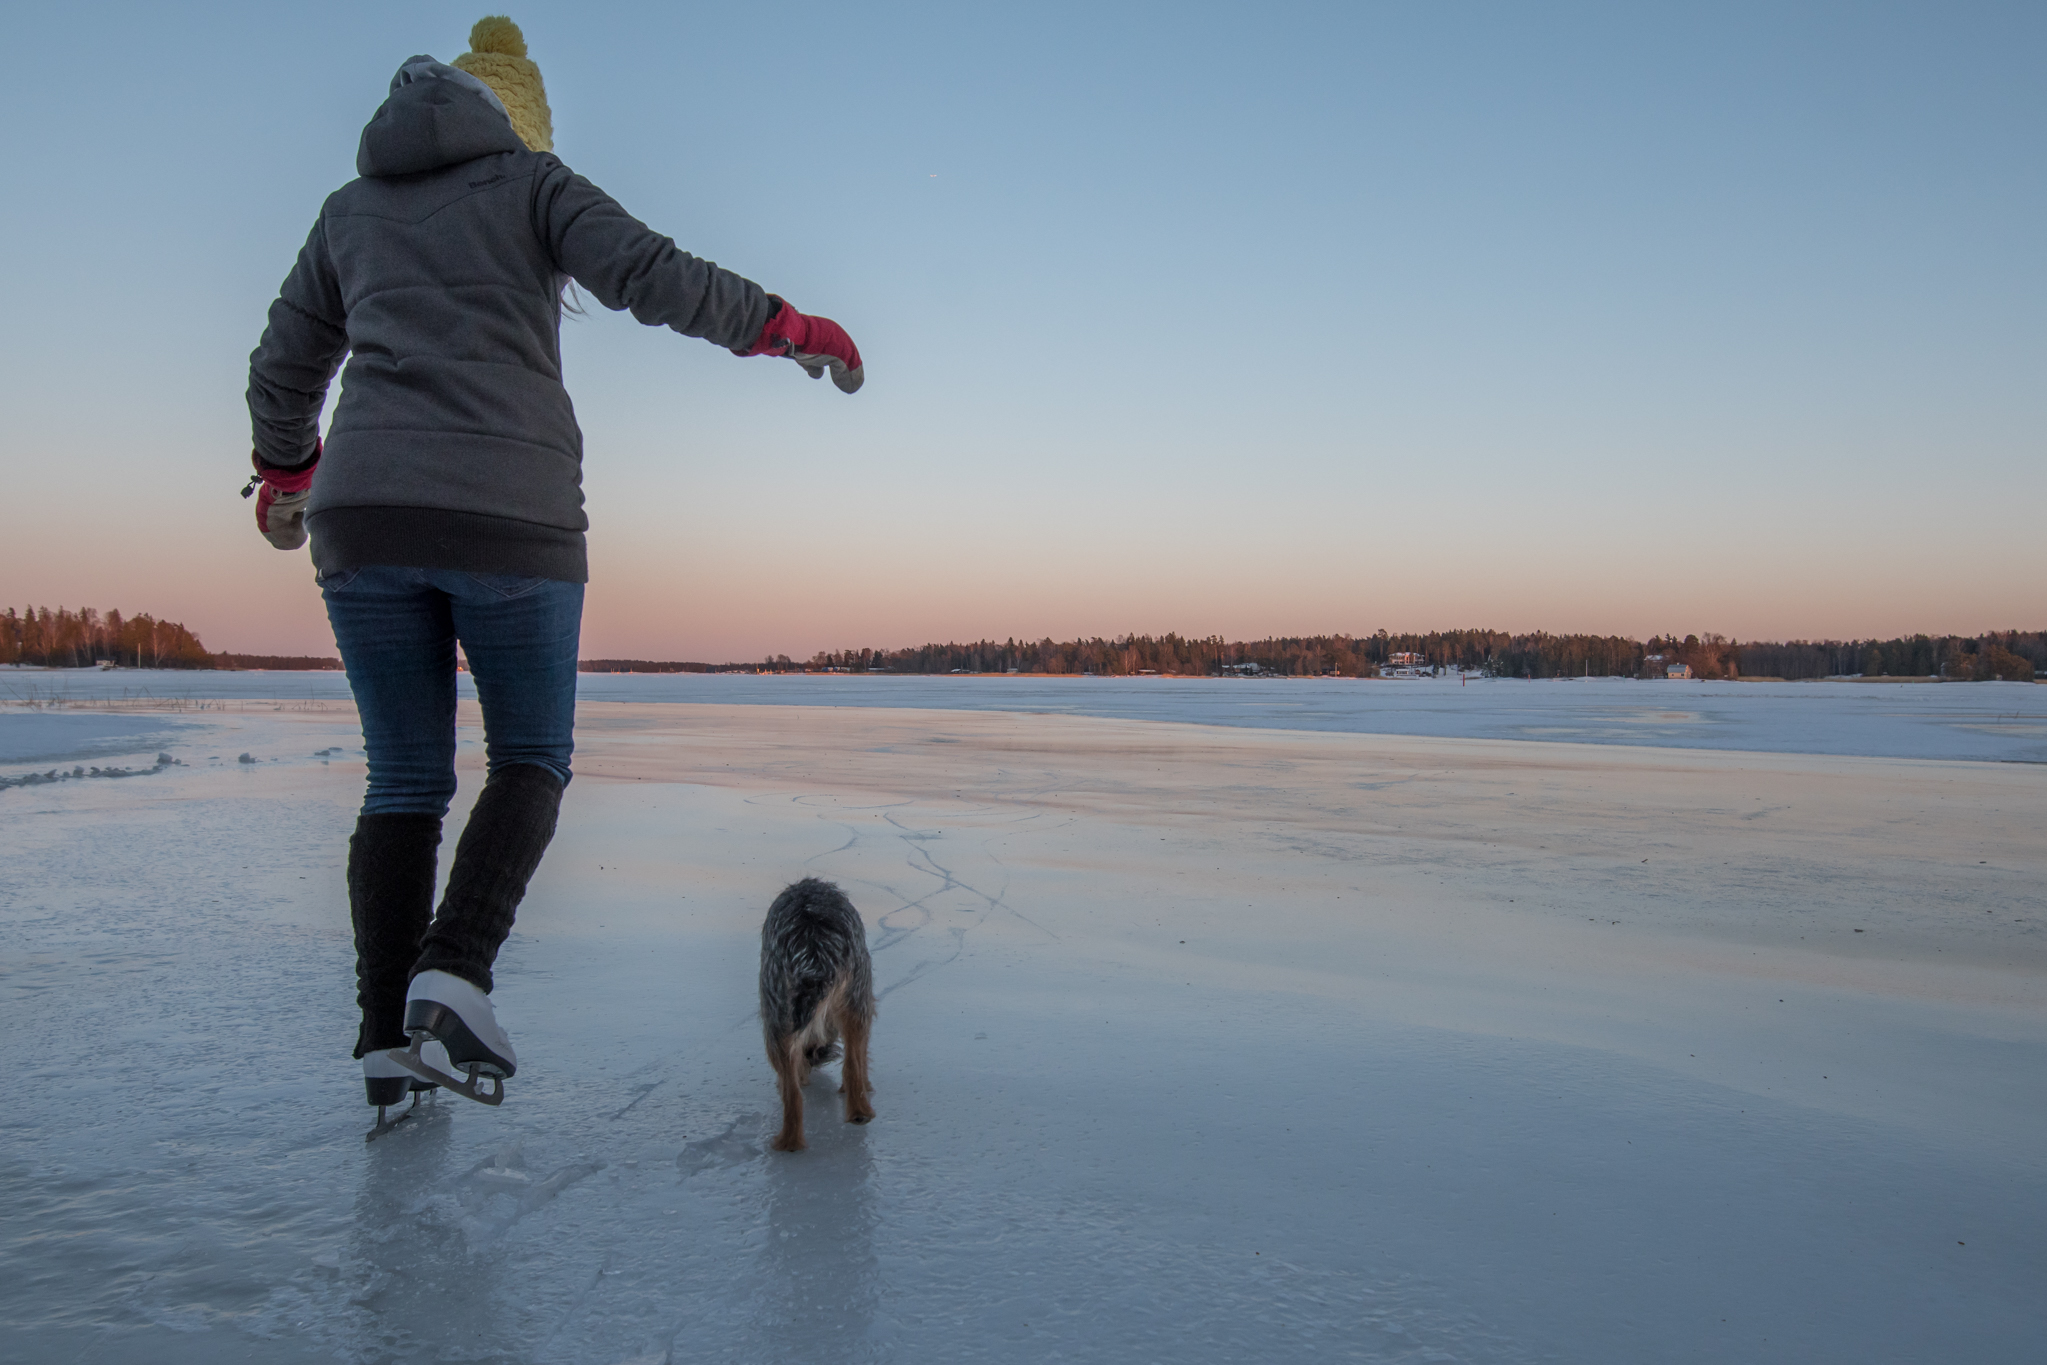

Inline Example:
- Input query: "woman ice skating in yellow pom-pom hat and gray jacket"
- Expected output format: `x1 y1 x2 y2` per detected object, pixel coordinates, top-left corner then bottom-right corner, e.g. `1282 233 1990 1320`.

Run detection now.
248 16 864 1124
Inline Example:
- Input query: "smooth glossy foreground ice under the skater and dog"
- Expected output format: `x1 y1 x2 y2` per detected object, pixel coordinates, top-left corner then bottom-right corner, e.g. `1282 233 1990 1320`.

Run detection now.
0 699 2047 1365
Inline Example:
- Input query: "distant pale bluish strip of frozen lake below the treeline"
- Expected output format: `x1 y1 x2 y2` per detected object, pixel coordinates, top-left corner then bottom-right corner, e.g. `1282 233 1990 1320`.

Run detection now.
0 669 2047 763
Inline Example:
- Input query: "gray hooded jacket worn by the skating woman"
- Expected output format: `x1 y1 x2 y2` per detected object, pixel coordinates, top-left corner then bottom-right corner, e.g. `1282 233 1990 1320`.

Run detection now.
248 57 772 583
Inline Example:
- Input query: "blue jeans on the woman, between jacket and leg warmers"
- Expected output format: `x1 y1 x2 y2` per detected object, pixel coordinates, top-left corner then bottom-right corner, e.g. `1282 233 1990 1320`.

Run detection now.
319 567 583 817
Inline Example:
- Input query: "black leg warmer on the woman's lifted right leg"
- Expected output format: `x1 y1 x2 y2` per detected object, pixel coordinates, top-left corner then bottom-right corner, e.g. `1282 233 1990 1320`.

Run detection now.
413 763 561 990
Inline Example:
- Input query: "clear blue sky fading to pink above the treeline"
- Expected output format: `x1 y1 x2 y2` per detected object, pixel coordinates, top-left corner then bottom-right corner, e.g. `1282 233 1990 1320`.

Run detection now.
0 0 2047 659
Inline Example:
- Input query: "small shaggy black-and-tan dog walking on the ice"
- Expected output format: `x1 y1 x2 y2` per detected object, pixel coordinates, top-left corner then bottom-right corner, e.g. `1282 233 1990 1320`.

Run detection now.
761 876 874 1152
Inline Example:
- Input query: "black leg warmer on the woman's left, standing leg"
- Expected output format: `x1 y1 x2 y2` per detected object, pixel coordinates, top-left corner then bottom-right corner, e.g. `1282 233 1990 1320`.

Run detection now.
348 814 440 1058
